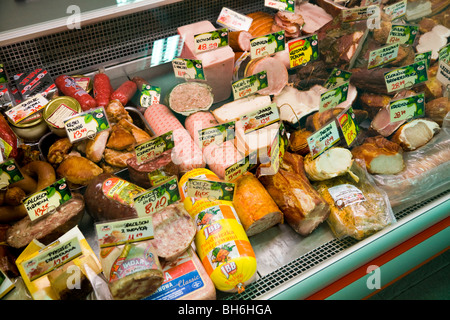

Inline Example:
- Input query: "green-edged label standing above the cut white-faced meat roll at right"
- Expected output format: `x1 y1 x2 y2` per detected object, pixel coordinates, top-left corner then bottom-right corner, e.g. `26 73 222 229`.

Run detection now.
389 93 425 122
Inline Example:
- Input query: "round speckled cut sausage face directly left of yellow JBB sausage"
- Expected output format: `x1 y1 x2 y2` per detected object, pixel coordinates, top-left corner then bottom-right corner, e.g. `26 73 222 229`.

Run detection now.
152 202 197 261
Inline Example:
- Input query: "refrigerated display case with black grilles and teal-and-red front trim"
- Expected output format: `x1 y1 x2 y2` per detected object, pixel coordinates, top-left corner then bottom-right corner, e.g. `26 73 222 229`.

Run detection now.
0 0 450 300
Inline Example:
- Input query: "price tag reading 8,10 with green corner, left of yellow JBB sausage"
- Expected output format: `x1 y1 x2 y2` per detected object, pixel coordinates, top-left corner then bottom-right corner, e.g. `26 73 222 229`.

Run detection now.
133 176 181 217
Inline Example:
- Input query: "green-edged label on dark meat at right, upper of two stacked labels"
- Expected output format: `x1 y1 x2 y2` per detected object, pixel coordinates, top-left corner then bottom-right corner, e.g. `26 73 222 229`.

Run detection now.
384 60 428 92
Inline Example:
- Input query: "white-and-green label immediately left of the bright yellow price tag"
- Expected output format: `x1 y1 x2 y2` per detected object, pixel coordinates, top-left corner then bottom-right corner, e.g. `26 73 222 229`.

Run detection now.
250 30 286 59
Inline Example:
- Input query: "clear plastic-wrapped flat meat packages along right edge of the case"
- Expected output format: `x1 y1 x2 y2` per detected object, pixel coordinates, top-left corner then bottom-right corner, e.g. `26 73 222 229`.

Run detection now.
373 113 450 207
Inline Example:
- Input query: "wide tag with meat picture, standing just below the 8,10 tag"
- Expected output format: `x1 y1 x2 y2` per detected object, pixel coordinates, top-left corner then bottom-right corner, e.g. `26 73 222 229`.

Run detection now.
95 216 154 248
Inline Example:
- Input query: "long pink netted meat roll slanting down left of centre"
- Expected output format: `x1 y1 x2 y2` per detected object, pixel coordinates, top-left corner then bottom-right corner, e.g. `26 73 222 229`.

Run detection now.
144 104 206 173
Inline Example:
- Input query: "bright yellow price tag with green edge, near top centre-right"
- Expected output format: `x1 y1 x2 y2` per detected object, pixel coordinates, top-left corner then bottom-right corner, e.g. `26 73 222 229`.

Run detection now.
288 34 319 68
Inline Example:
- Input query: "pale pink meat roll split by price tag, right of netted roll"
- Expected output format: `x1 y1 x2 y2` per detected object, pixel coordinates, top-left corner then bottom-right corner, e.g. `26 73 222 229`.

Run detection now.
185 112 242 179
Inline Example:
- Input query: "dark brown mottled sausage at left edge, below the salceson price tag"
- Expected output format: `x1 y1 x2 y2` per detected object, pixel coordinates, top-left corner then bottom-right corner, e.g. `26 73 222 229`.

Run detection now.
6 193 84 248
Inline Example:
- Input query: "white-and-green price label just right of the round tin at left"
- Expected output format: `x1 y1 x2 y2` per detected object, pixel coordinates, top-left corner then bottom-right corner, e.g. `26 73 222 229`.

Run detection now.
64 107 110 143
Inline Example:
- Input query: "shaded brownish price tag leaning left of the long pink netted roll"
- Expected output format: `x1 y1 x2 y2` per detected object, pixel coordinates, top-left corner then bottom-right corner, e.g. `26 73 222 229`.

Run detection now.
134 131 175 164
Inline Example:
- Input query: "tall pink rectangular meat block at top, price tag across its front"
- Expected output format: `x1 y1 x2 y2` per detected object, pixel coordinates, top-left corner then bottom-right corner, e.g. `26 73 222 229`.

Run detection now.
178 21 234 103
